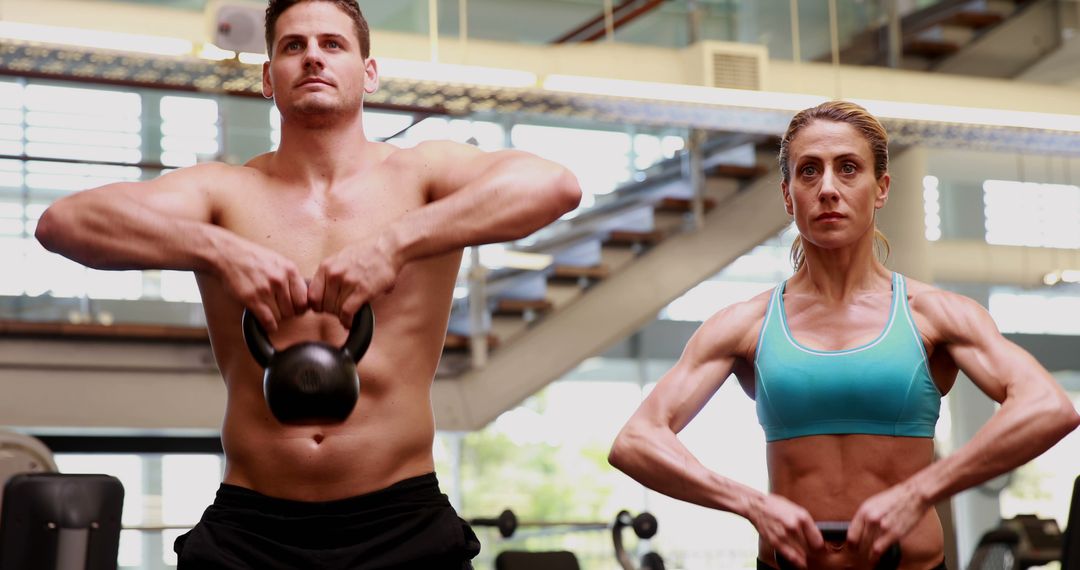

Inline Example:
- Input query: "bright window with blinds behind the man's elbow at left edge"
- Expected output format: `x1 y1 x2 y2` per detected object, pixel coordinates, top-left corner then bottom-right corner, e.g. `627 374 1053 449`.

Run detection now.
0 82 143 299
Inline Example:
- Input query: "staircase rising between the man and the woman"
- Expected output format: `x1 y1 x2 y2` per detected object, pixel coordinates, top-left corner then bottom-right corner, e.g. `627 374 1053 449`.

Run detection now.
434 134 788 430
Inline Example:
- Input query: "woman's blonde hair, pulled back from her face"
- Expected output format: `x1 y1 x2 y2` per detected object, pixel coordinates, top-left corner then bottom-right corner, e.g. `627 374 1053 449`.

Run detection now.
780 100 891 271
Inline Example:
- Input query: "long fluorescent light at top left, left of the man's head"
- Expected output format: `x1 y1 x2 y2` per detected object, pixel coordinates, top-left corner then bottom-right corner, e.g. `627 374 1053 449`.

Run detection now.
0 22 194 55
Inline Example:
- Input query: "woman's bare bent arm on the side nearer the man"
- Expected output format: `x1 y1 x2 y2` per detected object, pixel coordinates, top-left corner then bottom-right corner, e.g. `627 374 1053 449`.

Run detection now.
608 301 824 567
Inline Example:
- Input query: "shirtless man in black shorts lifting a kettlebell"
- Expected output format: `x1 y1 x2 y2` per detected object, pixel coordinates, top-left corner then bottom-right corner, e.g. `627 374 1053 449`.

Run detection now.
37 0 581 570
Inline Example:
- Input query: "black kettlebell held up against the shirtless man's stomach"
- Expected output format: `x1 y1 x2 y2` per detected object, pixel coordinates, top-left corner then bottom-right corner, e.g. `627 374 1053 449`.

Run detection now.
243 303 375 423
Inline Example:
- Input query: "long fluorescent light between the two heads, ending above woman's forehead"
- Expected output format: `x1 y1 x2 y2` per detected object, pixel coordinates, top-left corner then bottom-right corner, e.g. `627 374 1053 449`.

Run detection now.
543 74 826 111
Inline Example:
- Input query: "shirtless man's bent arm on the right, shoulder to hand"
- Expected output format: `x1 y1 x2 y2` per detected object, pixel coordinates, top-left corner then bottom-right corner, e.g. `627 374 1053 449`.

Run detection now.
309 141 581 326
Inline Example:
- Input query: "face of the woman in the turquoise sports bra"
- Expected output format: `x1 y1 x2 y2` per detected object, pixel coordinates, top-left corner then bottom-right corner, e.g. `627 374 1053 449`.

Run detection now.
781 120 889 249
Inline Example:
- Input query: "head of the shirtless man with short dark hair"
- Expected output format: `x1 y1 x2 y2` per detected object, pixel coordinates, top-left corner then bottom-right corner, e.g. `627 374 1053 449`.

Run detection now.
262 1 378 121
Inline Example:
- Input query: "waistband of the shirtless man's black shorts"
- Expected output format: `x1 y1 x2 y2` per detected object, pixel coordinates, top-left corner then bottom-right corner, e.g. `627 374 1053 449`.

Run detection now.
214 473 449 516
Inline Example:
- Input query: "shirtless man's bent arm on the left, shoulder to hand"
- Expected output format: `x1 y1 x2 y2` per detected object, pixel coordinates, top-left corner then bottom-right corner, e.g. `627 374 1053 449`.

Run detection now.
35 164 307 331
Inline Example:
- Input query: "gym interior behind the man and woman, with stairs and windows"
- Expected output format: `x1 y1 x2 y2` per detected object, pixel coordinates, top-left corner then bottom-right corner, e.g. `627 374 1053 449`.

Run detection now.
0 0 1080 570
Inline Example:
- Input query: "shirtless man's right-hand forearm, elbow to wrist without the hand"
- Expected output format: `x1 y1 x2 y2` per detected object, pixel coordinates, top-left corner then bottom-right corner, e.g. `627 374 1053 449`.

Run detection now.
386 158 581 263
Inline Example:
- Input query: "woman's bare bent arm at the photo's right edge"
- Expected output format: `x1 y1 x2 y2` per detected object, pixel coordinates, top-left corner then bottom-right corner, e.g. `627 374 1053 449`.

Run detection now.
848 291 1080 559
